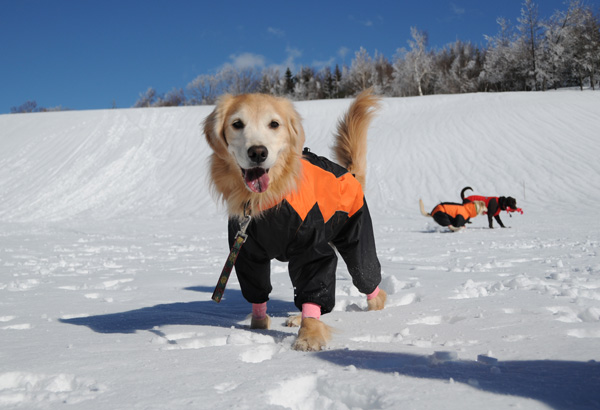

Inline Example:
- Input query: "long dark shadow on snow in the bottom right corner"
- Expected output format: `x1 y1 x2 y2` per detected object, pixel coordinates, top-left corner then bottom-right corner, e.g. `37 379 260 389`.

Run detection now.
317 350 600 410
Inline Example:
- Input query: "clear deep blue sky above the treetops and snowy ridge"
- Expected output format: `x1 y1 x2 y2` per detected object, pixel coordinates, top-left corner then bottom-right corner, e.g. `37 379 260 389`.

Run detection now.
0 0 580 113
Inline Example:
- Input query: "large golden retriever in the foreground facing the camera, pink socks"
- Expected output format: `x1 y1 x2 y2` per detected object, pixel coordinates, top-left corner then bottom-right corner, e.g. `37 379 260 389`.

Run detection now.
204 90 386 350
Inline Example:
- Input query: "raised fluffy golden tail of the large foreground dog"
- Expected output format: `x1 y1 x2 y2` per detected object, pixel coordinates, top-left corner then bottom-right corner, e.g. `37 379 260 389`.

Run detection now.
333 88 380 190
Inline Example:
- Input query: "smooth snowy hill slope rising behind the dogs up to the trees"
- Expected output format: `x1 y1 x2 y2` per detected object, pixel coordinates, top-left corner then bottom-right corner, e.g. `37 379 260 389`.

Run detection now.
0 91 600 221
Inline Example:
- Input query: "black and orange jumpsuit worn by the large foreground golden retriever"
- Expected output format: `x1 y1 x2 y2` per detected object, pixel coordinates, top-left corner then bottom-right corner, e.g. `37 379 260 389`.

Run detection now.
229 149 381 314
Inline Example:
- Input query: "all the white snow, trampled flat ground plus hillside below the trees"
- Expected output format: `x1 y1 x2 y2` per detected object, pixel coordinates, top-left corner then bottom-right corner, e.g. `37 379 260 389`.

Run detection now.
0 90 600 410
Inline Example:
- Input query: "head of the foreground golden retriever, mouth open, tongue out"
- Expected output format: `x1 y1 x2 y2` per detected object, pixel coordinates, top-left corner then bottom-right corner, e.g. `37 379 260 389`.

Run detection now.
204 94 304 193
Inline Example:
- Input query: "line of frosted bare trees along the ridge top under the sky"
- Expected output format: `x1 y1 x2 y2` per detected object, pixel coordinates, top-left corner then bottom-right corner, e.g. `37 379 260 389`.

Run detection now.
135 0 600 107
